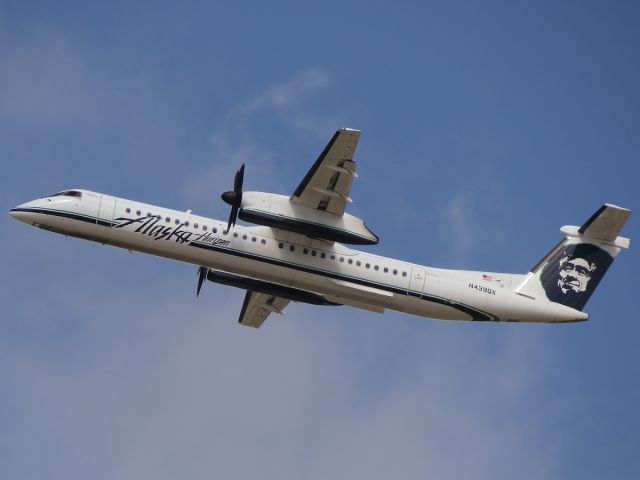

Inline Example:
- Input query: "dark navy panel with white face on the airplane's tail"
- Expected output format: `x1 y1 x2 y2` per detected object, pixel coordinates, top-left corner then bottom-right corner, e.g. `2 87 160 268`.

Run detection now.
540 243 613 309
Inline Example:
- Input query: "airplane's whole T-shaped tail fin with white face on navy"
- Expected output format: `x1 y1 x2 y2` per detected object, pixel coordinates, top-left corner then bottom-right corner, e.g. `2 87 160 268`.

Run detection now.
516 204 631 310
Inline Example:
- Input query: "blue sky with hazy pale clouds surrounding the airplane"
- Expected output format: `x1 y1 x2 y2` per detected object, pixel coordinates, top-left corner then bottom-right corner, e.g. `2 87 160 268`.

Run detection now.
0 1 640 479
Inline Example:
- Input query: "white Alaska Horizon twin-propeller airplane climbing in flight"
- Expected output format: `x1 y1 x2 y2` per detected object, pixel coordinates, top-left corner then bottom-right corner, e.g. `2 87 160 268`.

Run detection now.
10 128 631 328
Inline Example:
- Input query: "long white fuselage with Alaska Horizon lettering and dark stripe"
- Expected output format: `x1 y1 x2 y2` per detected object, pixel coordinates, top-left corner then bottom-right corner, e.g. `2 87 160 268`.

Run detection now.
11 190 588 322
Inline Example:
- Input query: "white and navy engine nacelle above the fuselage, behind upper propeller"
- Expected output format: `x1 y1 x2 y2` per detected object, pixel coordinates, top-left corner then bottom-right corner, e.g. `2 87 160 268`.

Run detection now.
239 192 378 245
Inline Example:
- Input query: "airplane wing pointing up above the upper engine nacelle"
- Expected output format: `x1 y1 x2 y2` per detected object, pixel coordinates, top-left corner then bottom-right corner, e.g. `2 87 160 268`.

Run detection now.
291 128 360 216
